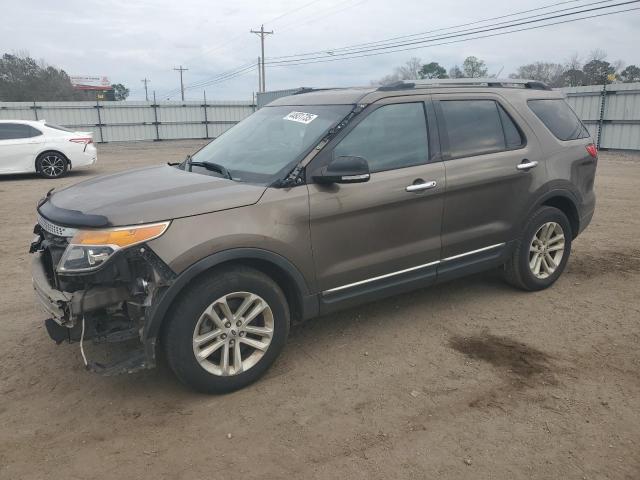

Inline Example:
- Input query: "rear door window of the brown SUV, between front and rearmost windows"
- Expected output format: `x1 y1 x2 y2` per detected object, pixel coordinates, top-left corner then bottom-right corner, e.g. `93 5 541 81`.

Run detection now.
440 100 524 158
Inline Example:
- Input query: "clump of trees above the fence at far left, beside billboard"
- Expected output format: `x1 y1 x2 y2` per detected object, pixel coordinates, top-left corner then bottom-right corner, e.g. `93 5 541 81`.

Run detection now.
0 53 75 102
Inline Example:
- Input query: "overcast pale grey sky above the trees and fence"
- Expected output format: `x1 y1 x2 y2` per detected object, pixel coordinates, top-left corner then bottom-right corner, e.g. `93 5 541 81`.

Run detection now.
5 0 640 100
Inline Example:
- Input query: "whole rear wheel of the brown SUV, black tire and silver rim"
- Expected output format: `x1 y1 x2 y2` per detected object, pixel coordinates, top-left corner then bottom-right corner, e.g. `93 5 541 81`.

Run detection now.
504 206 572 291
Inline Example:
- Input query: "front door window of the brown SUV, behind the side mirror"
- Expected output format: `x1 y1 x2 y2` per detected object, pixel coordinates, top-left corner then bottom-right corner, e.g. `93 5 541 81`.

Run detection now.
333 103 429 172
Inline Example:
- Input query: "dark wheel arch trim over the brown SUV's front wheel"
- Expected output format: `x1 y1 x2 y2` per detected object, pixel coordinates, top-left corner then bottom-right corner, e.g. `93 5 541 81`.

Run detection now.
144 248 319 340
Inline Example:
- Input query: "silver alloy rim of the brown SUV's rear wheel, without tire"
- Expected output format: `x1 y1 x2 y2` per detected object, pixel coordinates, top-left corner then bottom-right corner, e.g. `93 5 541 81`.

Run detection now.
529 222 565 279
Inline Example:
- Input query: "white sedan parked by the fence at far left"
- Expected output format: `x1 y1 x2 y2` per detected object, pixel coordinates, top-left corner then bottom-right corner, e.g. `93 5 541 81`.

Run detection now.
0 120 97 178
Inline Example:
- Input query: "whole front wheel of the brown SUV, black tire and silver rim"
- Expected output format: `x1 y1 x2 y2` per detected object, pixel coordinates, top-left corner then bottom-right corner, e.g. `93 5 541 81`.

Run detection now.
161 266 290 393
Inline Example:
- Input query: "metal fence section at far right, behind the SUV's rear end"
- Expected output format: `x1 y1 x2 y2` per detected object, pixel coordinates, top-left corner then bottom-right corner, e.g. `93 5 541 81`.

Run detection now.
561 83 640 150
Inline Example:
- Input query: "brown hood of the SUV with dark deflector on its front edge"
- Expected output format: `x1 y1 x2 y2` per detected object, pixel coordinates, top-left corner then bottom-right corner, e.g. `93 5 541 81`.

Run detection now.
38 166 266 227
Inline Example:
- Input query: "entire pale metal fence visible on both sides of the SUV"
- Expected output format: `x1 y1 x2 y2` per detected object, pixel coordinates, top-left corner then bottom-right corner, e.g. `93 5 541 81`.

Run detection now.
0 83 640 150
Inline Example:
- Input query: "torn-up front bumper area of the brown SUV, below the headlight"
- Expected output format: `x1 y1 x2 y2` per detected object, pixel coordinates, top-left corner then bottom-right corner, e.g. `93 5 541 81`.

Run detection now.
31 227 175 375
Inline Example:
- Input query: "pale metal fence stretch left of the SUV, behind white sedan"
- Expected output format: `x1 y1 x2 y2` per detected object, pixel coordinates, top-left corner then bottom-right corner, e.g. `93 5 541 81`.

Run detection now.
0 101 255 142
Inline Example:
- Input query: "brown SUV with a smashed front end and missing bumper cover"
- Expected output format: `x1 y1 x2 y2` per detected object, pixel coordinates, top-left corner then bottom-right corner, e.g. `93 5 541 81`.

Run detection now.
31 79 597 392
